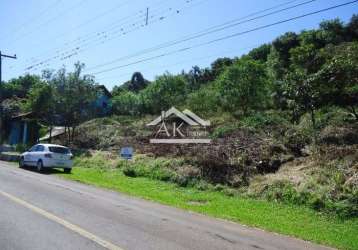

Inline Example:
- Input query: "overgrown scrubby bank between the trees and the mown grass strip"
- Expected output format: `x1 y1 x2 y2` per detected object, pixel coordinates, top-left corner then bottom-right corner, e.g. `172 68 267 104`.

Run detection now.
63 109 358 216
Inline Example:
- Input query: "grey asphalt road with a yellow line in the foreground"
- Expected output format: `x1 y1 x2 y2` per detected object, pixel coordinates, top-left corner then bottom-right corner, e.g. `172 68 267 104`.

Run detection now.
0 162 328 250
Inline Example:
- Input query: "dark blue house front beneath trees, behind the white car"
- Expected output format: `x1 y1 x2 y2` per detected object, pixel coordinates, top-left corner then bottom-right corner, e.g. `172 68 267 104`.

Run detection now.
8 112 40 145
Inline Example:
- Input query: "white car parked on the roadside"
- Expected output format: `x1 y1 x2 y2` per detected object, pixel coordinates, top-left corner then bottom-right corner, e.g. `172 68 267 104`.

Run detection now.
19 144 73 173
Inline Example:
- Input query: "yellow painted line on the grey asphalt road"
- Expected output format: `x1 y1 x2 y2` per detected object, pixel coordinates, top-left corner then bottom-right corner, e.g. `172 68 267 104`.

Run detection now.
0 190 124 250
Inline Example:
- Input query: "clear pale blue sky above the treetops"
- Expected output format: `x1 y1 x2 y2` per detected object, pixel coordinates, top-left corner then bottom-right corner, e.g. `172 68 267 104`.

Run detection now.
0 0 358 90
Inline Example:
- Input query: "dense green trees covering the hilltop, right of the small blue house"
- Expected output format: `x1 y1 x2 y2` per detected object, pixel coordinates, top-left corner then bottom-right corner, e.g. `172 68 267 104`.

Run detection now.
113 15 358 126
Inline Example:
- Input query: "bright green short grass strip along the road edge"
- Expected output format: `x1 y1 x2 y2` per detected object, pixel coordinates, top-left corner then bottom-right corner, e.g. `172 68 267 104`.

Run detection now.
60 168 358 250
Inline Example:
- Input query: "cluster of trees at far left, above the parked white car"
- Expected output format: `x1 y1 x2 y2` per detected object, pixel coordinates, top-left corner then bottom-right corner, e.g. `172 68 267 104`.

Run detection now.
0 63 99 141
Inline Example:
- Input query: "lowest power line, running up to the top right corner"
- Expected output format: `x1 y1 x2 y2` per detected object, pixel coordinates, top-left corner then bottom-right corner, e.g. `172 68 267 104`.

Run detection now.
93 0 358 75
